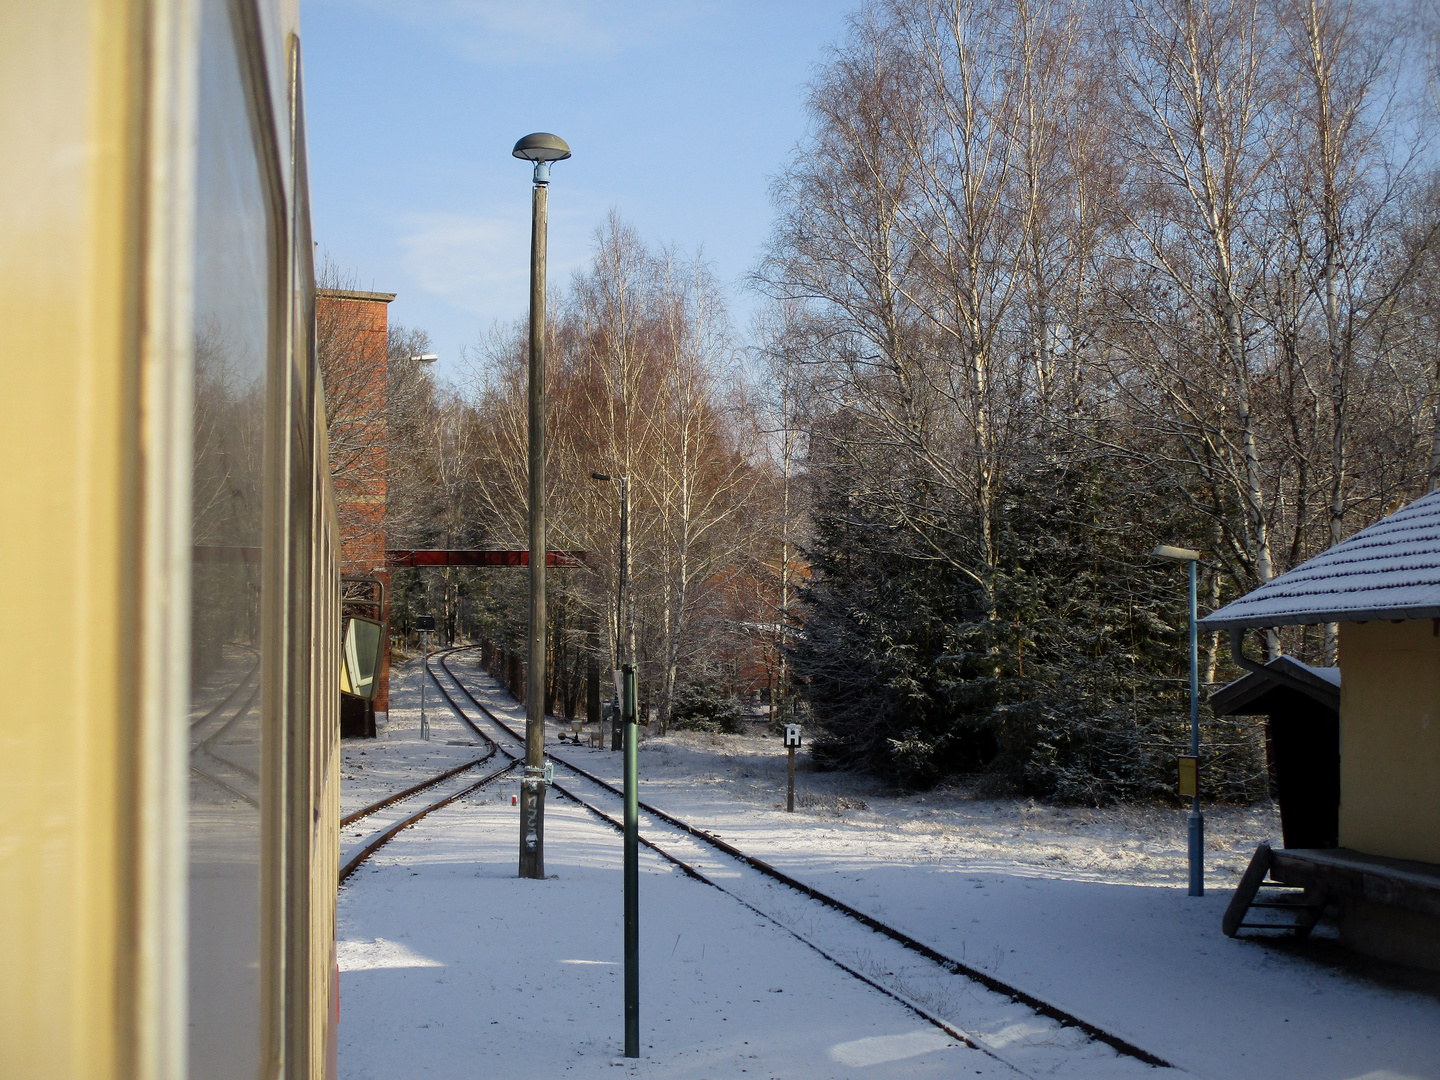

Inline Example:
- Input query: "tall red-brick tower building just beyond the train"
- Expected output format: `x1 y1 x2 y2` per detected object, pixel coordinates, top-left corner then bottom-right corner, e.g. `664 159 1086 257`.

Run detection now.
315 288 395 734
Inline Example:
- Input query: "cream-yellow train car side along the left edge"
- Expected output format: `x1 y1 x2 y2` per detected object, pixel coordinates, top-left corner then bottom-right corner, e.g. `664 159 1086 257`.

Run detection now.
0 0 340 1080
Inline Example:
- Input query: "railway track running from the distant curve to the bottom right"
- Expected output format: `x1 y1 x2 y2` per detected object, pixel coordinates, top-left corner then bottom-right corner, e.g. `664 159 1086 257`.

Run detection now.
429 647 1174 1076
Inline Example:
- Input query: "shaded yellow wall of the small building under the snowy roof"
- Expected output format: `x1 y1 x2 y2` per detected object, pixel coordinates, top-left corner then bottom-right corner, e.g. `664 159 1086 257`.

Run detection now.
1339 619 1440 863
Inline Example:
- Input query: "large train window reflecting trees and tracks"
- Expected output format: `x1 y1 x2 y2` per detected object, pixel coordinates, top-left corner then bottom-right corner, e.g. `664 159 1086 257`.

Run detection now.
189 0 278 1080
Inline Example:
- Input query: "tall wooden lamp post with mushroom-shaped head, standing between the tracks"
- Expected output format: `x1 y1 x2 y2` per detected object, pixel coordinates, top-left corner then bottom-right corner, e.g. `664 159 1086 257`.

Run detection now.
511 131 570 878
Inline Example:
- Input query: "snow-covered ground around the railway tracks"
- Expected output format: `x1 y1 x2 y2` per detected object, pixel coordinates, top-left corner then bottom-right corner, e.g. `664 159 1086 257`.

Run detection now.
340 654 1440 1080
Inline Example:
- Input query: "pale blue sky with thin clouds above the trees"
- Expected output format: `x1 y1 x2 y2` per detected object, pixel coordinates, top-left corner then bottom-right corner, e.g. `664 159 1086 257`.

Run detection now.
301 0 858 373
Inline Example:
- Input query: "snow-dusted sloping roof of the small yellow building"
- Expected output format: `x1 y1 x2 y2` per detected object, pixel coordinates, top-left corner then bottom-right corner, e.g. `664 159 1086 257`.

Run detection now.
1201 491 1440 629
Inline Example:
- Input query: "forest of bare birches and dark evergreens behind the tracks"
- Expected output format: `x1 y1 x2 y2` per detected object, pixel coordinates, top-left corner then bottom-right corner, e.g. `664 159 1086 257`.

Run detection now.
318 0 1440 804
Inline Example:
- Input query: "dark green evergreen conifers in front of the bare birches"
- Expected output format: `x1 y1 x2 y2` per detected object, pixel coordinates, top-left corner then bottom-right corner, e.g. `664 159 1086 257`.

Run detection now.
795 426 1266 805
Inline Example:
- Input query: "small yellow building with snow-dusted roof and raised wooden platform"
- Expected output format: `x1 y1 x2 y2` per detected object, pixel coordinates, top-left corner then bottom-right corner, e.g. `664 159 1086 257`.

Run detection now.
1201 492 1440 969
